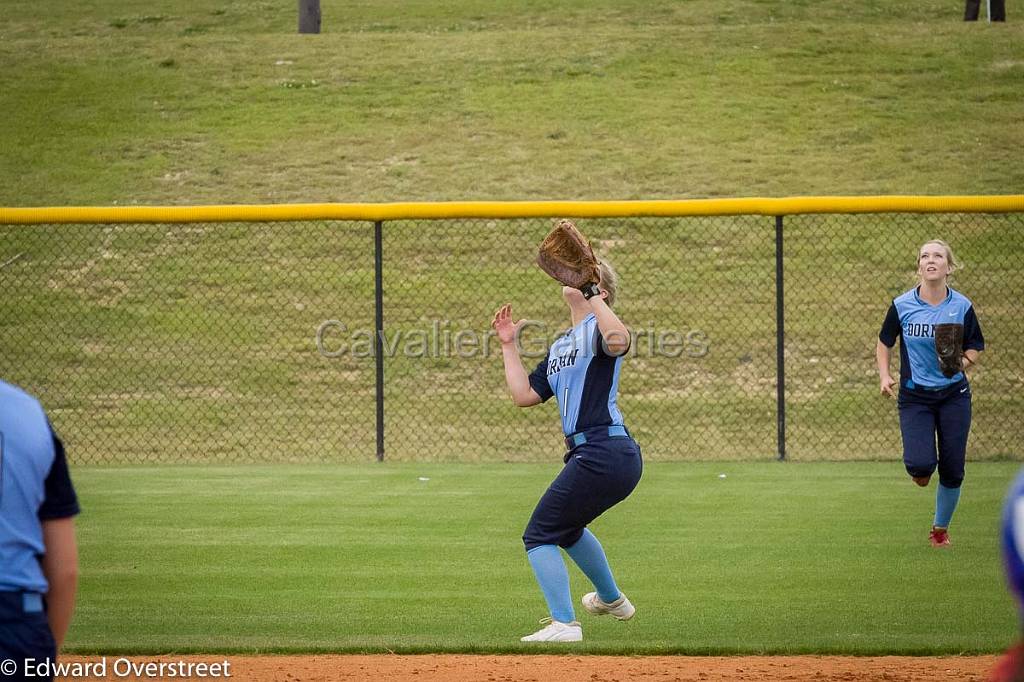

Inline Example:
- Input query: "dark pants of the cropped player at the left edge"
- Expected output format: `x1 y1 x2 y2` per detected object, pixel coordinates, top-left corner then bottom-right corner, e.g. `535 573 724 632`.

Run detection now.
0 592 57 680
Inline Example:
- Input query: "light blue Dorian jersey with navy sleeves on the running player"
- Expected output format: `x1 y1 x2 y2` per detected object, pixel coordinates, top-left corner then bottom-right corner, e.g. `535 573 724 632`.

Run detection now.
879 287 985 389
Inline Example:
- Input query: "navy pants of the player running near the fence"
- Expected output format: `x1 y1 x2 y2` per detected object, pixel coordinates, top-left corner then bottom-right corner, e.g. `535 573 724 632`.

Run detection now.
899 380 971 487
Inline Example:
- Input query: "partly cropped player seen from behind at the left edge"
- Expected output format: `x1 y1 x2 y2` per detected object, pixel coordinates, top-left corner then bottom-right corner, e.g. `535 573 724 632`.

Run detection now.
0 381 78 679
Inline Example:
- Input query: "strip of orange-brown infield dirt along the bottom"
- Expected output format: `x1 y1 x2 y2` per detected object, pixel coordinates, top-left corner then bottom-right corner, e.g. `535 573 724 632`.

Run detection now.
57 654 996 682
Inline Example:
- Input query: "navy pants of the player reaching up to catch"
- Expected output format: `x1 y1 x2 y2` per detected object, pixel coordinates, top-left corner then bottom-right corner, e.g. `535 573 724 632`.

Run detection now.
522 426 643 551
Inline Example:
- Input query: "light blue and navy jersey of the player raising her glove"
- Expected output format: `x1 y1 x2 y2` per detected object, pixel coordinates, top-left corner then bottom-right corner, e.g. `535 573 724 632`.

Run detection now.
529 313 623 435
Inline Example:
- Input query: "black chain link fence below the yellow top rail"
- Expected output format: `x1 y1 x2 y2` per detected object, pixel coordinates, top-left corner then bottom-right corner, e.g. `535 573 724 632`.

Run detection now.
0 214 1024 464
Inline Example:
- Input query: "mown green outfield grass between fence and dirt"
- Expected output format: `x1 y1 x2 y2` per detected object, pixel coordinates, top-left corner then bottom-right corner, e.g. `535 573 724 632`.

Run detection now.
67 461 1017 654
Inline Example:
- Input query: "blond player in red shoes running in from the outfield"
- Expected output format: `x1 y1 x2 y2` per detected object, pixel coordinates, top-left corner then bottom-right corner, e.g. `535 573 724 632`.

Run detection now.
876 240 985 547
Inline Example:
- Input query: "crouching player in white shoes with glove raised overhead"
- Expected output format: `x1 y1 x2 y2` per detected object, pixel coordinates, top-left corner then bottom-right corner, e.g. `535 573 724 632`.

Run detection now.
492 256 643 642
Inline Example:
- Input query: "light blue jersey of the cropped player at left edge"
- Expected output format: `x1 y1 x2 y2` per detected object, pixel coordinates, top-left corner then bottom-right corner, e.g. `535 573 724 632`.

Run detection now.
0 381 79 593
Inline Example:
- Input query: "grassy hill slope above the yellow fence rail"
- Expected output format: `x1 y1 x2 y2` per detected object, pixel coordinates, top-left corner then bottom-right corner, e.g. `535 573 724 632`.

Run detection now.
0 0 1024 206
